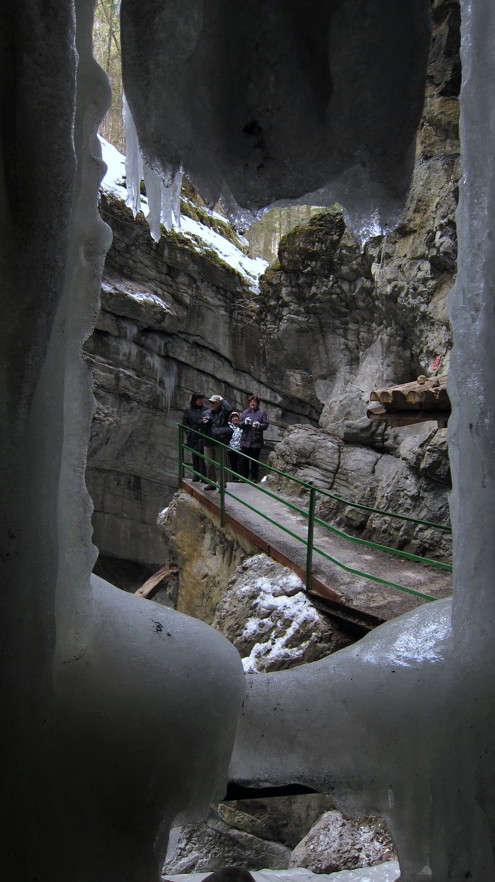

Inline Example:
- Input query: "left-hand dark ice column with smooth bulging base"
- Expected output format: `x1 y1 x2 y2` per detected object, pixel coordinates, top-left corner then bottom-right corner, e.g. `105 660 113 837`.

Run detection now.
0 0 243 882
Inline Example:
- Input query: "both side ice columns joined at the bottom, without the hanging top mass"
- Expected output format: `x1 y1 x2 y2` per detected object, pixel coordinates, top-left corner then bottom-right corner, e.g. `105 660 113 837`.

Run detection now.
5 0 495 882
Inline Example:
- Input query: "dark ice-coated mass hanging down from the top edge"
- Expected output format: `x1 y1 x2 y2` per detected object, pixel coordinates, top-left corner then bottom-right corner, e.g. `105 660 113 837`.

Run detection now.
122 0 429 235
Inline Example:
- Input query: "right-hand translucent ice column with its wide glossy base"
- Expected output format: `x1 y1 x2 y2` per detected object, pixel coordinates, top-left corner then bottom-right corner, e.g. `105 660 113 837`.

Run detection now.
232 0 495 882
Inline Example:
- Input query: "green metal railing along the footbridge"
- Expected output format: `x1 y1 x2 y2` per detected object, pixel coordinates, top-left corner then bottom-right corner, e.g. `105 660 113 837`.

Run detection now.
178 424 452 601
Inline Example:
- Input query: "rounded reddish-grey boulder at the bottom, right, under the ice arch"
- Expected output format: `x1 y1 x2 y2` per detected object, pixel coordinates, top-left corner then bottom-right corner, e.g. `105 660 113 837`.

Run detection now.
289 811 395 873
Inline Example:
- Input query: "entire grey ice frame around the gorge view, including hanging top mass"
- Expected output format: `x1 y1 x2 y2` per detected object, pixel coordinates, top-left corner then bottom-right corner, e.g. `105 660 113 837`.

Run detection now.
0 0 495 882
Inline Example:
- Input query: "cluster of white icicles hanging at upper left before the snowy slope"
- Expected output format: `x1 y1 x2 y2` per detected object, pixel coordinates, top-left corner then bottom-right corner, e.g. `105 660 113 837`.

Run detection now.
124 95 182 242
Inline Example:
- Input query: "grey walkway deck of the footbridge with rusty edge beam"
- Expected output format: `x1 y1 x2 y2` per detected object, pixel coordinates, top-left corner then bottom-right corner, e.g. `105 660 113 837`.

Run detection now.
181 479 452 627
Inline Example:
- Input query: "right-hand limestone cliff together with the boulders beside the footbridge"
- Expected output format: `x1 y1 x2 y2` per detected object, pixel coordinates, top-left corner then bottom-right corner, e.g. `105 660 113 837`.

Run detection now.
260 0 460 554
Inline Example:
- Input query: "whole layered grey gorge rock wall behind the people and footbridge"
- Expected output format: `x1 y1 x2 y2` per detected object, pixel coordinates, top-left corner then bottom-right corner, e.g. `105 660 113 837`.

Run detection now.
86 0 460 568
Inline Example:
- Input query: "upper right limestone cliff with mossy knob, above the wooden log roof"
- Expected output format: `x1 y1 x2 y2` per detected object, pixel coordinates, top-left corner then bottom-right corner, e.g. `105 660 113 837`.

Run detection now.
261 0 460 443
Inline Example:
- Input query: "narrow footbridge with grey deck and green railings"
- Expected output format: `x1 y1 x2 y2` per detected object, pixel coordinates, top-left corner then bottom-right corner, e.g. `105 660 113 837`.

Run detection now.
179 426 452 629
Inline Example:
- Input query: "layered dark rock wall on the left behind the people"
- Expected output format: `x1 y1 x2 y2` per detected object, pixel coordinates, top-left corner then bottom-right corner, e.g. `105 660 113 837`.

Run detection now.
85 193 321 567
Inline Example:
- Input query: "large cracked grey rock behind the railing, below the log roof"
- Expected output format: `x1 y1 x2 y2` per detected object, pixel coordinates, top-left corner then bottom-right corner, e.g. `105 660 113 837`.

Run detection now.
269 423 452 558
